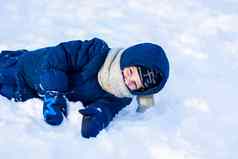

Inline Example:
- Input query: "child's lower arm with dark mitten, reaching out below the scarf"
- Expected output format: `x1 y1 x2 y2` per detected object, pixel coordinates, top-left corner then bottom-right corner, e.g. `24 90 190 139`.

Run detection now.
79 98 132 138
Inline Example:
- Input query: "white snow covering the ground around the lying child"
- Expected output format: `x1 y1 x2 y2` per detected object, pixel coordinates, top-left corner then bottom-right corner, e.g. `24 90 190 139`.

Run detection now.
0 0 238 159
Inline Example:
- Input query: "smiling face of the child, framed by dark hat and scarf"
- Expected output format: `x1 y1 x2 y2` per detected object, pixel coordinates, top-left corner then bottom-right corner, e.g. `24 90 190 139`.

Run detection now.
122 66 143 90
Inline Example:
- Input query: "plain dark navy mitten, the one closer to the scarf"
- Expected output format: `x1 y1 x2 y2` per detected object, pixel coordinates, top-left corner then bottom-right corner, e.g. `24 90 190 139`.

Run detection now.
79 107 108 138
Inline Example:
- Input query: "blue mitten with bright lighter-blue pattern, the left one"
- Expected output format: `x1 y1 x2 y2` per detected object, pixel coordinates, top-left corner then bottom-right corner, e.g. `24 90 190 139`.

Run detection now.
43 91 68 125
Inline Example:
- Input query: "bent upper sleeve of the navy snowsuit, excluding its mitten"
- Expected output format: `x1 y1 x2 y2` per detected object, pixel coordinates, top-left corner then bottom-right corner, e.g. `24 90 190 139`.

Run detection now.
40 38 109 92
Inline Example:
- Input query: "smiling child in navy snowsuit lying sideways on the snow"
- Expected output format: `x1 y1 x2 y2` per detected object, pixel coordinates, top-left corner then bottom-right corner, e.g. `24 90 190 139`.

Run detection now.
0 38 169 138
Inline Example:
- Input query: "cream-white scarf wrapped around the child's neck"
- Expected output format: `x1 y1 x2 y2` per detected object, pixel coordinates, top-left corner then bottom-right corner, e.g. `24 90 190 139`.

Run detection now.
98 48 133 98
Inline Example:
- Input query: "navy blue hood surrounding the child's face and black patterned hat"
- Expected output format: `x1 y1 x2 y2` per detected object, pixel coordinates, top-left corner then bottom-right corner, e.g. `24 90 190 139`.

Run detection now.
120 43 169 95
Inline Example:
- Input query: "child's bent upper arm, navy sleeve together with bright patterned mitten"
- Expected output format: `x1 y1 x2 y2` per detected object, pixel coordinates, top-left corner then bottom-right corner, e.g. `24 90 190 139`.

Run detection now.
34 38 109 125
